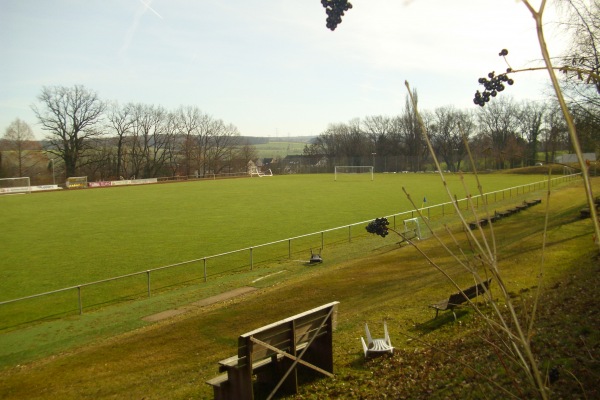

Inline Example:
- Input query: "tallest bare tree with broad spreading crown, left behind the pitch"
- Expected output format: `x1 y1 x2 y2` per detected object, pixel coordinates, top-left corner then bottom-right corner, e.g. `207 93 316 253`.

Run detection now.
32 85 105 176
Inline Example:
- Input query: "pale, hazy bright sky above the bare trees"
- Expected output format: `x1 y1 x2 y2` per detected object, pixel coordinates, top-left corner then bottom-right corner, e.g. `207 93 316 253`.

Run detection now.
0 0 560 138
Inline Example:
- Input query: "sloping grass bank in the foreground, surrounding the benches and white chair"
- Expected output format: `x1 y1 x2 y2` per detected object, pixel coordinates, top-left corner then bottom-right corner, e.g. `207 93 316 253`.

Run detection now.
0 179 600 399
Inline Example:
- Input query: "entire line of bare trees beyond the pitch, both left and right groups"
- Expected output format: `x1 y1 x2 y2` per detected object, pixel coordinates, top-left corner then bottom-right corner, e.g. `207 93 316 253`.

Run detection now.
0 85 599 186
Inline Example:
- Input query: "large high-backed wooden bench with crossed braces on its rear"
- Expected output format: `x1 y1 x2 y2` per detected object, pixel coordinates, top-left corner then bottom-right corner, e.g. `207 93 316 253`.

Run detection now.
206 301 339 400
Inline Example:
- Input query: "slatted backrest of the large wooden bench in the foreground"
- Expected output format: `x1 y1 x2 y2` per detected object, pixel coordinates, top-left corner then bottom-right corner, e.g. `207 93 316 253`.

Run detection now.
238 301 339 367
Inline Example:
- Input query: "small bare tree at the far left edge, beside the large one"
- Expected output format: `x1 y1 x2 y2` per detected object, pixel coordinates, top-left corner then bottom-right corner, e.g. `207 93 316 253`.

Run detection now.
0 118 41 176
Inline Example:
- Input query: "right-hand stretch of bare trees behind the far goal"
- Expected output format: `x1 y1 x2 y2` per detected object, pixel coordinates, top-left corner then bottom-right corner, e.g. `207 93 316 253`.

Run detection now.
304 90 599 172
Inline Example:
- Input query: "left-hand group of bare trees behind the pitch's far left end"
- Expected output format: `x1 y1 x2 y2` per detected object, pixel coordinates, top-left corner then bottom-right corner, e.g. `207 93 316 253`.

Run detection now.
0 85 256 180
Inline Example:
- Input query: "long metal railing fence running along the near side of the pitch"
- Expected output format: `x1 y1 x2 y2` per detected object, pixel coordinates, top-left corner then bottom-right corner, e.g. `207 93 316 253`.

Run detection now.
0 174 580 329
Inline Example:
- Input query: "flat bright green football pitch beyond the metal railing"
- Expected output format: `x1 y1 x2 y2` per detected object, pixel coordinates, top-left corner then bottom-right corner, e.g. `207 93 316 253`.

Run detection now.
0 174 545 301
